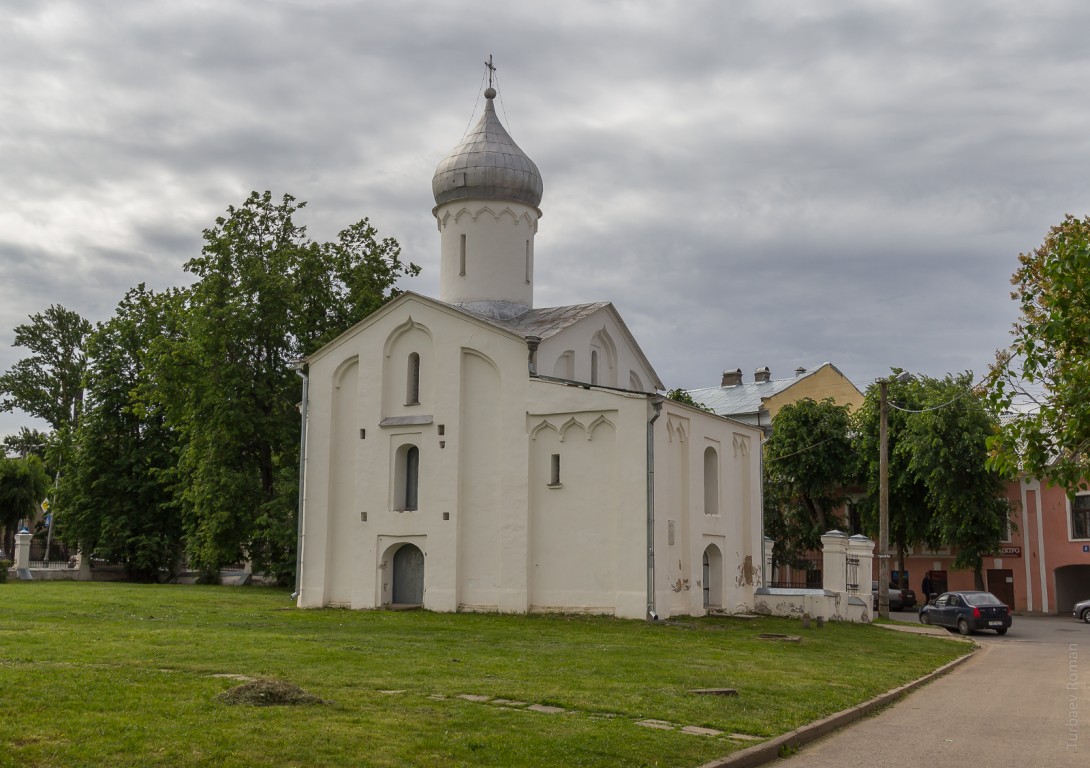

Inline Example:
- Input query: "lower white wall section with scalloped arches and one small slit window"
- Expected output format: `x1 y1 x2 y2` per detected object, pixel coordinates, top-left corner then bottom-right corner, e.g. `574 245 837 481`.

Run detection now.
526 380 649 619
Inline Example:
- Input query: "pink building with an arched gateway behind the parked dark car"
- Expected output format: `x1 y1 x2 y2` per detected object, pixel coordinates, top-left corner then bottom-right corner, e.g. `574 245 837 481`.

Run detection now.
893 478 1090 613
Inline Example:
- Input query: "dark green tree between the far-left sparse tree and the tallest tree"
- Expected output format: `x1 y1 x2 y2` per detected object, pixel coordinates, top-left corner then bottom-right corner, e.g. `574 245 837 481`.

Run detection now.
53 284 183 582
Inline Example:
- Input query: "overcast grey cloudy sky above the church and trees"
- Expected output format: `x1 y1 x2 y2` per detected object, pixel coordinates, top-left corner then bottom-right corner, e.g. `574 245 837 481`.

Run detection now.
0 0 1090 434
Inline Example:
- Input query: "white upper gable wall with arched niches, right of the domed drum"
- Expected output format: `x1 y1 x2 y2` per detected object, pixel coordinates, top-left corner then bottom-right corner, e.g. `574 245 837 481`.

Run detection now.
537 308 656 392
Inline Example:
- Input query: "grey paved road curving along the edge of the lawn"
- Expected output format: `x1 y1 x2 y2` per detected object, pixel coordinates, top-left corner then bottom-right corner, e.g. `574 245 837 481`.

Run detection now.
776 622 1090 768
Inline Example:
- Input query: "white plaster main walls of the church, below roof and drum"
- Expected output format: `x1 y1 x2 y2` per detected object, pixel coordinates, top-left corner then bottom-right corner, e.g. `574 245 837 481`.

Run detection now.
299 295 760 619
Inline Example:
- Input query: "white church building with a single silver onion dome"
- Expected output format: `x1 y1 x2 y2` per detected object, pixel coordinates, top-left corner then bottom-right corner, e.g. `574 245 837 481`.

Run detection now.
296 80 762 619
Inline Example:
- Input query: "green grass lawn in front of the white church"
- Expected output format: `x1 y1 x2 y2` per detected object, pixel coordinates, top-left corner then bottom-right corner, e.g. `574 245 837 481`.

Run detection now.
0 582 969 768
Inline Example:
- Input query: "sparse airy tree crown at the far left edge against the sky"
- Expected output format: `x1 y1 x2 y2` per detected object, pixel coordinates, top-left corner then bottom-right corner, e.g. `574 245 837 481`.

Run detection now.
0 304 92 431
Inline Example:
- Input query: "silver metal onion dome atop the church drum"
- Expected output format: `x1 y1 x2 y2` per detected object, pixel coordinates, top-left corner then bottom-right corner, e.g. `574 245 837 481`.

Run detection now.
432 87 543 208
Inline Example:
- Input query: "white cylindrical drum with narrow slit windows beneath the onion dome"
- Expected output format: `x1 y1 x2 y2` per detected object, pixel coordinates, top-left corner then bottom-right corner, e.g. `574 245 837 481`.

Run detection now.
435 199 541 307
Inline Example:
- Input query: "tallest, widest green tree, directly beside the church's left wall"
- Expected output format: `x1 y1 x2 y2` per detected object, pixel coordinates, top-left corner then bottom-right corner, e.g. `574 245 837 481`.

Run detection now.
155 192 419 578
